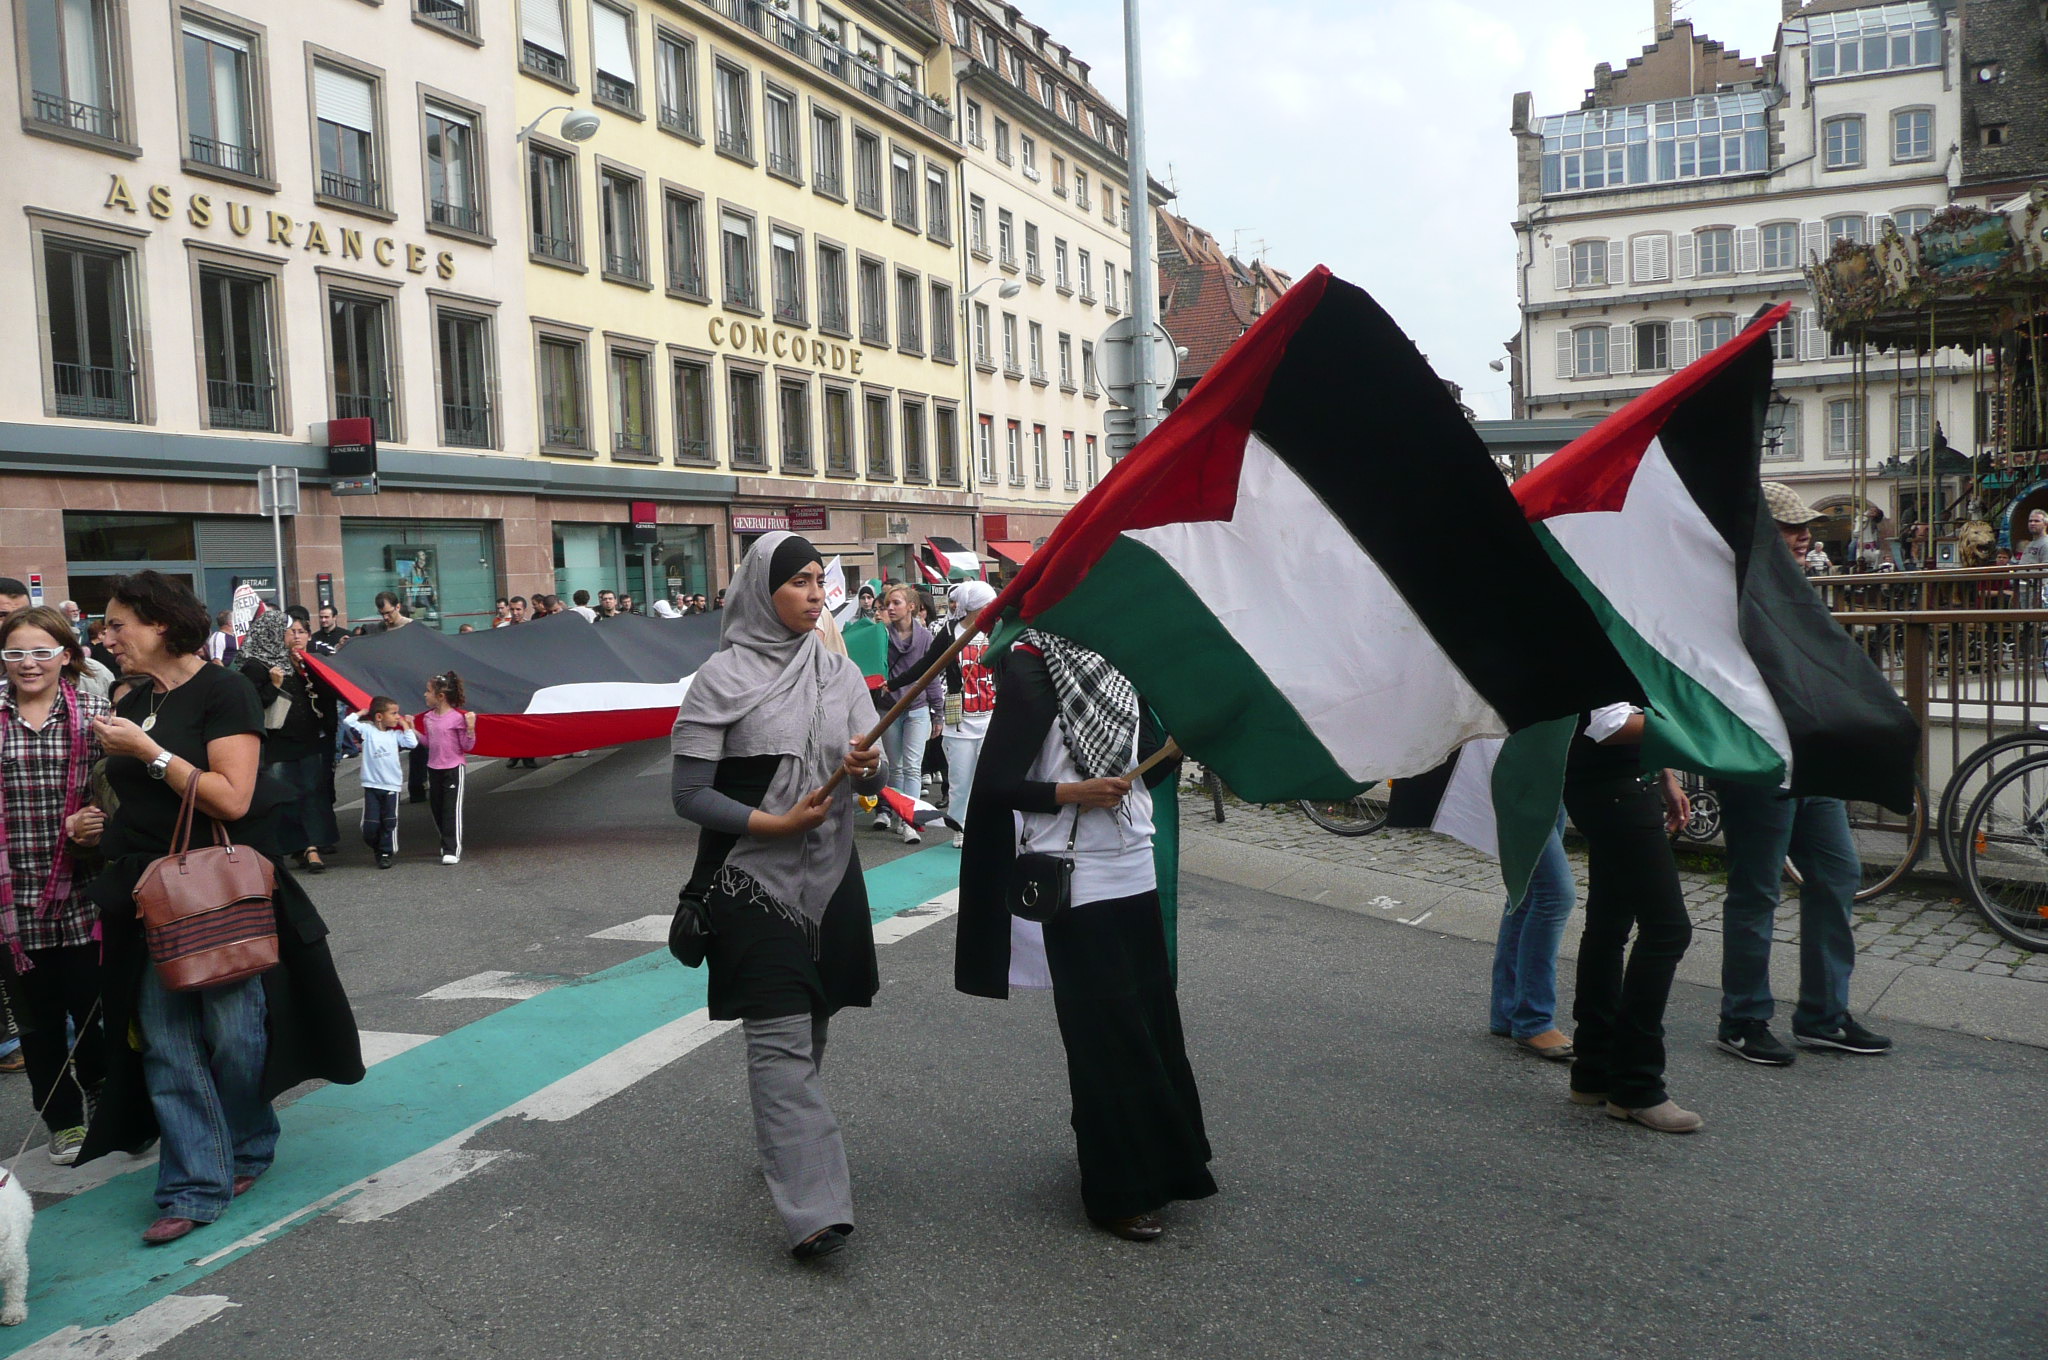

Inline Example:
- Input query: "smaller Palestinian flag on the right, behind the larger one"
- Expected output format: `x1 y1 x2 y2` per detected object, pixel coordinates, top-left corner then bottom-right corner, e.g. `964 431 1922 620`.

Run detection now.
1513 303 1919 811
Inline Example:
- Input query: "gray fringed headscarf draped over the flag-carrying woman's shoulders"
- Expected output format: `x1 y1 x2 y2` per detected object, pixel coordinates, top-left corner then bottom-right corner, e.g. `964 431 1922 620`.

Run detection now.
670 533 874 948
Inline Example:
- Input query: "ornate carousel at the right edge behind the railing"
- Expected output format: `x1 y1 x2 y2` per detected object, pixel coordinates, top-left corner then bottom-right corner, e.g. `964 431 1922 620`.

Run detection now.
1808 184 2048 567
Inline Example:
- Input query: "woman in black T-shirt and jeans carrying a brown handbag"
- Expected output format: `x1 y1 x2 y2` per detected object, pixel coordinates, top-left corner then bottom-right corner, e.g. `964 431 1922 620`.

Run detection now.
80 571 362 1245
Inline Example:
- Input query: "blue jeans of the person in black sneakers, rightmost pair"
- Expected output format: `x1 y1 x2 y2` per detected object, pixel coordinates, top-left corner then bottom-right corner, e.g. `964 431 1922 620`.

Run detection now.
1712 780 1864 1030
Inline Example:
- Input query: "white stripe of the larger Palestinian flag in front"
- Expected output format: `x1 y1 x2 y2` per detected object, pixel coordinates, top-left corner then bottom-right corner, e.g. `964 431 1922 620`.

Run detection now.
1128 436 1507 780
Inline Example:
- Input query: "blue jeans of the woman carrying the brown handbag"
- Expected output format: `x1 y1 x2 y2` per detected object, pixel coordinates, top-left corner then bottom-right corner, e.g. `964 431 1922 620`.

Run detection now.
137 965 279 1223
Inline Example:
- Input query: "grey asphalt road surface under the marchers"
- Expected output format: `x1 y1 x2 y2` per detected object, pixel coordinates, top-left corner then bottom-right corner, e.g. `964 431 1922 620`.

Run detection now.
4 750 2048 1360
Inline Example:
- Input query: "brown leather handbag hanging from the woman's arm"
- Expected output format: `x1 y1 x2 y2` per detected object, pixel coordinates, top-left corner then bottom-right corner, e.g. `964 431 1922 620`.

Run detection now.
135 774 276 991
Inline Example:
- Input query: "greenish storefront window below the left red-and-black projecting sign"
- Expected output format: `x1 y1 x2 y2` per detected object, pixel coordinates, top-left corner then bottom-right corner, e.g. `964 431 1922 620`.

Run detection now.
342 520 498 633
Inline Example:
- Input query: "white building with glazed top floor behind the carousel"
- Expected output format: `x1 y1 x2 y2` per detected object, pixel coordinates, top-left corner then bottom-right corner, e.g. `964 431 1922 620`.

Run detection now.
1509 0 1978 553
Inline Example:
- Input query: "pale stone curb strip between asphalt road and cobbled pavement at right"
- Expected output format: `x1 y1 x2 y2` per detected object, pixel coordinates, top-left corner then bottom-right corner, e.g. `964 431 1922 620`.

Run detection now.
1180 827 2048 1049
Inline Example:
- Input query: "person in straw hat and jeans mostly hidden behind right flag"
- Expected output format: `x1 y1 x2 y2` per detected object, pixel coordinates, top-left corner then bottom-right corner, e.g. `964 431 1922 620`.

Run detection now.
1710 481 1892 1067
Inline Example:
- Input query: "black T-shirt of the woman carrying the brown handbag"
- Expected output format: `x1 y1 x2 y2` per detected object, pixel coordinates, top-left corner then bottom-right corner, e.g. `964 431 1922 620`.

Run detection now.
104 666 268 856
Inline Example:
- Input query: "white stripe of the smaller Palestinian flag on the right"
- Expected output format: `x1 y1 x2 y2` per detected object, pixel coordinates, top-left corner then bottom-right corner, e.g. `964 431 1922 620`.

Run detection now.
1542 440 1792 774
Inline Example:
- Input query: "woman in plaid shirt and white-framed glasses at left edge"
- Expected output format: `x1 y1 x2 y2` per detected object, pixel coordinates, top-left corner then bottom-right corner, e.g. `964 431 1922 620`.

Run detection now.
0 606 109 1165
